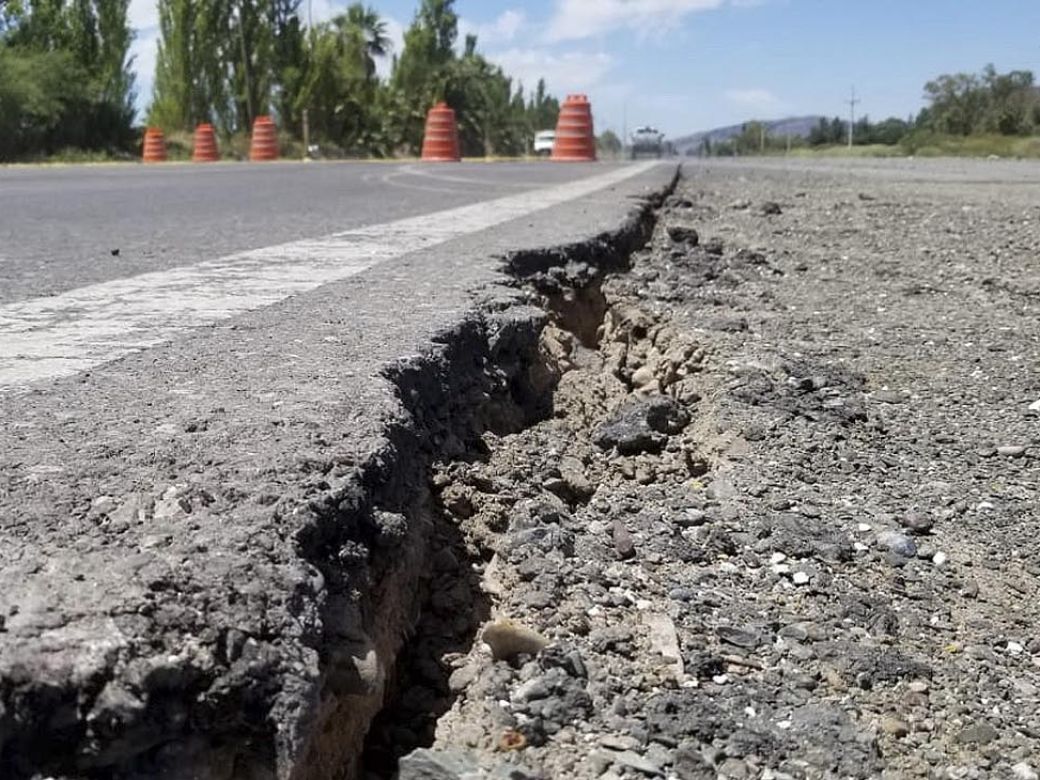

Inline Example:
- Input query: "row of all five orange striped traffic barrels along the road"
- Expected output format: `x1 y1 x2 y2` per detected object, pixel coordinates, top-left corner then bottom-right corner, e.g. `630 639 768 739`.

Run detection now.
142 95 596 162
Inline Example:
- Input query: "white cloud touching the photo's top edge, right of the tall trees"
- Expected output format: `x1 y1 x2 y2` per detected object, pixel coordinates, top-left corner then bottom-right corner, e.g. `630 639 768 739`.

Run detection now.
547 0 727 42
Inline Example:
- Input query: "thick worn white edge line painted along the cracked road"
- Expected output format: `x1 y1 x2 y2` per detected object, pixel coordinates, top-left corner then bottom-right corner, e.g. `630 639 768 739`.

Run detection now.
0 162 655 390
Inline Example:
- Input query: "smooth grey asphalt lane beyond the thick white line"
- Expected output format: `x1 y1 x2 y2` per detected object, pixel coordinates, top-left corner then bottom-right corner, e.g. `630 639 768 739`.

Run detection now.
0 162 640 304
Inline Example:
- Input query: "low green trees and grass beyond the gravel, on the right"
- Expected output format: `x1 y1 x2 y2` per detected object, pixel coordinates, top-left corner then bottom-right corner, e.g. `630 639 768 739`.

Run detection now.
700 64 1040 162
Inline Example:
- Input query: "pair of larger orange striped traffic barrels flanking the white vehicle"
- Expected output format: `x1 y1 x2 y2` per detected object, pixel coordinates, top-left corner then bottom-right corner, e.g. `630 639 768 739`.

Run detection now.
422 95 596 162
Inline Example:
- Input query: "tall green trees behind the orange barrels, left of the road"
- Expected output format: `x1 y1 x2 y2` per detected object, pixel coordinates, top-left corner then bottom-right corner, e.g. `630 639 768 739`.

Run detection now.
0 0 560 161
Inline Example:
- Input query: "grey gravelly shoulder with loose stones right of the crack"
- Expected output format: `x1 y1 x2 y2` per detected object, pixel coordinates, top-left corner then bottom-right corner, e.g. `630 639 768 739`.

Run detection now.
388 160 1040 780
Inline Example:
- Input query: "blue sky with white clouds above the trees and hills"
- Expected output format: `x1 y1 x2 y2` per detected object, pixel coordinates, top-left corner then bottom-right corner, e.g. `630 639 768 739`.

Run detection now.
130 0 1040 137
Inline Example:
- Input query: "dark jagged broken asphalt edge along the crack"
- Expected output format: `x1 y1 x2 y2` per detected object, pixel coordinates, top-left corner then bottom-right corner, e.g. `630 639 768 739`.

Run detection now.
0 162 680 780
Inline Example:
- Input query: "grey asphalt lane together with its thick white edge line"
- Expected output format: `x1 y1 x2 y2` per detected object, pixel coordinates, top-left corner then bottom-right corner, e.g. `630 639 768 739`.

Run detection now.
0 163 661 389
